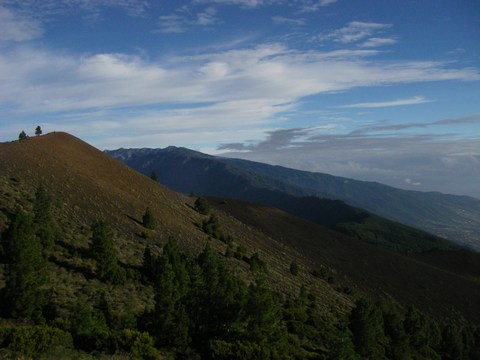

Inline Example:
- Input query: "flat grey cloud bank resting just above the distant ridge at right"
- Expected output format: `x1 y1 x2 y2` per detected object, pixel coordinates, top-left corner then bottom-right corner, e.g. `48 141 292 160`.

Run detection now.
219 115 480 198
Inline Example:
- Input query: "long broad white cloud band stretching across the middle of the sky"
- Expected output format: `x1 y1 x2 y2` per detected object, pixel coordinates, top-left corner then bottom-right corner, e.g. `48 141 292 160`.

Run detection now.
0 44 480 115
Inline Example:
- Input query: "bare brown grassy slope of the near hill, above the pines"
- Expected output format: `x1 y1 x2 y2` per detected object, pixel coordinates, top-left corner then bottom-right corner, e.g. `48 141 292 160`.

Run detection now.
0 132 352 311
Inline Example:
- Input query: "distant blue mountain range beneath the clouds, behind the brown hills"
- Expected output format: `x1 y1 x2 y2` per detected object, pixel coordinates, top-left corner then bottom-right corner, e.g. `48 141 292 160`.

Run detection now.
107 147 480 250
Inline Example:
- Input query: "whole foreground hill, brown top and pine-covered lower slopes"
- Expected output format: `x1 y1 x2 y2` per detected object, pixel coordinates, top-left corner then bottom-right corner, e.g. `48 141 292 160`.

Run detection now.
0 133 480 359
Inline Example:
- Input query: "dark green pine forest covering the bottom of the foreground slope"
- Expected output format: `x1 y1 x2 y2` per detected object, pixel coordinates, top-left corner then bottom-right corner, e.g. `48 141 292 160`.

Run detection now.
0 186 480 359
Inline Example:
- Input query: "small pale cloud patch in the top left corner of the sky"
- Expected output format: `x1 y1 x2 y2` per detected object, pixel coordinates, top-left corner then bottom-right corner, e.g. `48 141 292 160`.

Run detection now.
0 6 43 44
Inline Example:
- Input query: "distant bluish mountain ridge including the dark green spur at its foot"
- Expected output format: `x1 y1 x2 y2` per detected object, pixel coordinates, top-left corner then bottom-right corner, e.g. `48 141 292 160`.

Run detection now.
107 147 480 252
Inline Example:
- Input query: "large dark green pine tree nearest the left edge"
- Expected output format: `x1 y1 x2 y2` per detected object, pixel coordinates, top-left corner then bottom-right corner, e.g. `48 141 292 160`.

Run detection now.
5 210 48 319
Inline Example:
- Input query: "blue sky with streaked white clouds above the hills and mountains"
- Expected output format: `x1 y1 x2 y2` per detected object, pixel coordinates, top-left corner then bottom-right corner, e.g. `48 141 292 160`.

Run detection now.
0 0 480 198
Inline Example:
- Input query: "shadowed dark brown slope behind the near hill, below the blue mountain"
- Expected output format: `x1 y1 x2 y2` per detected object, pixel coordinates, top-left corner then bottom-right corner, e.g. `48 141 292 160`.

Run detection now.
211 199 480 321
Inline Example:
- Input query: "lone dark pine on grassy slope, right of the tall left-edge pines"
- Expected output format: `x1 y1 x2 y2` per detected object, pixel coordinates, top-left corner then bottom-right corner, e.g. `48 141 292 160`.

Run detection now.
90 220 125 283
